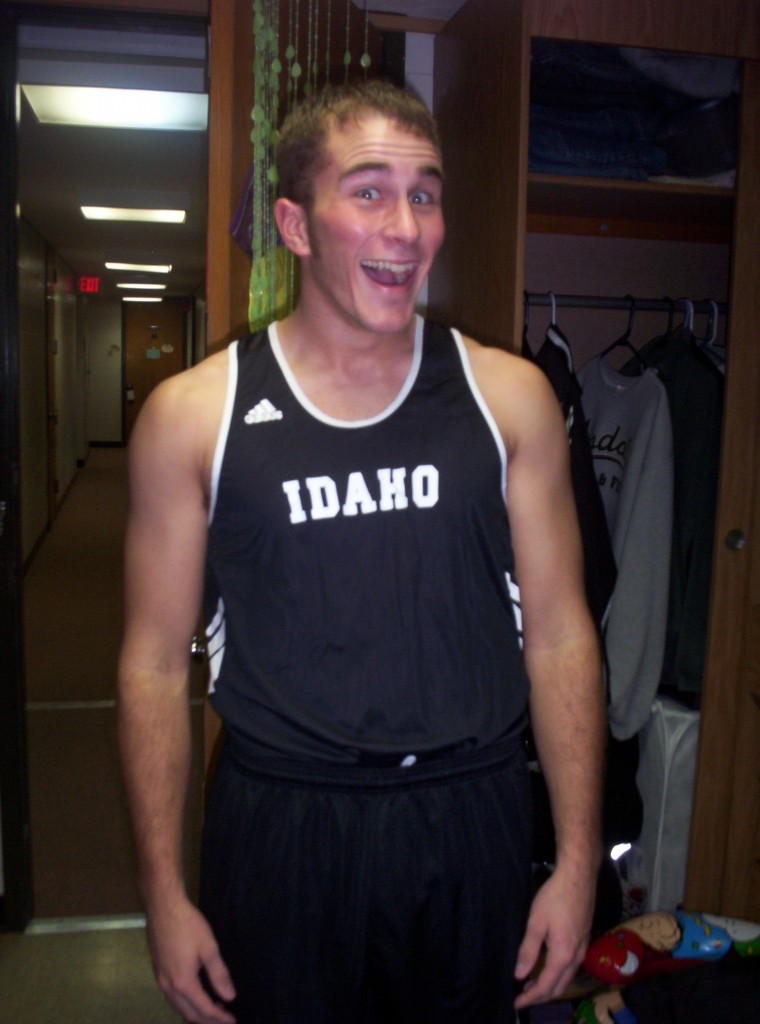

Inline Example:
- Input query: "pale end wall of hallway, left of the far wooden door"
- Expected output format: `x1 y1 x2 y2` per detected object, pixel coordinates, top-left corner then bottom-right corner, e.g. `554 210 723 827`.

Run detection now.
83 298 123 444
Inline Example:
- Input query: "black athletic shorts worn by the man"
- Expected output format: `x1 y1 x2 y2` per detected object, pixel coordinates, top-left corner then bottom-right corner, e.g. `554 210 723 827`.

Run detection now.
201 742 531 1024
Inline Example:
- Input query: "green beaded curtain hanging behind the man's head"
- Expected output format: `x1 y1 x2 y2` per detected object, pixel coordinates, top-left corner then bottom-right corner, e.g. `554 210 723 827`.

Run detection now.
247 0 372 331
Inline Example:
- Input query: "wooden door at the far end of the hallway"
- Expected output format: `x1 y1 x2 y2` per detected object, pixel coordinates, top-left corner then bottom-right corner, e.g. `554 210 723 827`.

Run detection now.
124 300 184 439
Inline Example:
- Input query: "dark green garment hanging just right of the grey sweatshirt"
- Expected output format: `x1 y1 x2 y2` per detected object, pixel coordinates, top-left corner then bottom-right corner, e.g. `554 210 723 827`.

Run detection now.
624 326 725 703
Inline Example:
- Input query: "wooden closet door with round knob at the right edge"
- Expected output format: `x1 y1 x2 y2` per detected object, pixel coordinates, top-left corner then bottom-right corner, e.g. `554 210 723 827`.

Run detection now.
685 60 760 920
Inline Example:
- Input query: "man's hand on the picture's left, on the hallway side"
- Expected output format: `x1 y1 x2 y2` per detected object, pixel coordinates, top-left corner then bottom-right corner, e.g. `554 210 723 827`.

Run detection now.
147 899 235 1024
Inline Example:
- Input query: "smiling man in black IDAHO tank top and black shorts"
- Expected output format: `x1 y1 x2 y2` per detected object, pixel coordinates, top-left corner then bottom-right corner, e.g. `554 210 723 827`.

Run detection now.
120 83 603 1024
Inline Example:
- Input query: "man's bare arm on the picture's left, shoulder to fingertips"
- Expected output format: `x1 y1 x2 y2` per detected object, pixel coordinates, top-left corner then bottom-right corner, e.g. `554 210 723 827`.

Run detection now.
119 362 234 1024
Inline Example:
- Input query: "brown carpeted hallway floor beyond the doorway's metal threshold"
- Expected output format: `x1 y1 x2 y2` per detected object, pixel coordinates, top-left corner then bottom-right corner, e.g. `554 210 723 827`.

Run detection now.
24 447 203 920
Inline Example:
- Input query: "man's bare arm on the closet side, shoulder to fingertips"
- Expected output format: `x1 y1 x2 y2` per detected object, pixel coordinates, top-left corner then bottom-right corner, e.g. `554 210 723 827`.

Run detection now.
472 350 605 1007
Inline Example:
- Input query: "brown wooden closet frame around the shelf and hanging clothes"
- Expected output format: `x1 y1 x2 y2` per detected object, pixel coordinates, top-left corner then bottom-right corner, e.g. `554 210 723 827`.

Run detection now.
429 0 760 921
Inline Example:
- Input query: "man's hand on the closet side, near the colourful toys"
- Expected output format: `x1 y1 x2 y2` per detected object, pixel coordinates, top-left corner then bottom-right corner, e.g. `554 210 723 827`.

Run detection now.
514 868 595 1010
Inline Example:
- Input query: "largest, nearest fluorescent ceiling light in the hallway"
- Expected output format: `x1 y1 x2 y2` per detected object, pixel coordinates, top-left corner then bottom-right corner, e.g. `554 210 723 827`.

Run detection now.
22 85 209 131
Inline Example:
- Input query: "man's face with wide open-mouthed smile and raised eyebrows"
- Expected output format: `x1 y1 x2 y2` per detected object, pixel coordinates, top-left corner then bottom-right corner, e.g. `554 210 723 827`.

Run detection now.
304 113 444 333
